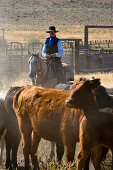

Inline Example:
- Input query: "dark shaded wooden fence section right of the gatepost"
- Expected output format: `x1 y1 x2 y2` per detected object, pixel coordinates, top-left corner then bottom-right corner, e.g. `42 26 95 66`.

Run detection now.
79 49 113 72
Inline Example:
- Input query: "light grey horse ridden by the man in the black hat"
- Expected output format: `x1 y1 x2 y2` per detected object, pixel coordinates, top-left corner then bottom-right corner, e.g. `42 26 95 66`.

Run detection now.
28 52 74 88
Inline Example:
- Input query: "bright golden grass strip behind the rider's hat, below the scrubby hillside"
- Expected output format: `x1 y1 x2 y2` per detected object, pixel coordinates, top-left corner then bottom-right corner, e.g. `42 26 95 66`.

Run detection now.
2 25 113 42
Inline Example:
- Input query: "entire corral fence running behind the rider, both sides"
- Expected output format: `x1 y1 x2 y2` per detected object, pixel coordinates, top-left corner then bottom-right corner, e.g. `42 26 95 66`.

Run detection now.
0 40 113 74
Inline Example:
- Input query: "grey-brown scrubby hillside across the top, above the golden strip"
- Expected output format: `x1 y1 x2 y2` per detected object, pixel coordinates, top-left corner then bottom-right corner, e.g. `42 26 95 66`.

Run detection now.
0 0 113 29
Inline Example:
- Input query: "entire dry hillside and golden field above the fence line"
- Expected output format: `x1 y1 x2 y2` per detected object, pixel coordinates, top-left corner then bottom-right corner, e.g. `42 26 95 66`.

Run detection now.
0 0 113 42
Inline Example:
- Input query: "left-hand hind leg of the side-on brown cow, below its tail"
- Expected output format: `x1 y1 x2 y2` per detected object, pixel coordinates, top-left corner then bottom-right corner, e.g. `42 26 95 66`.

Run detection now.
18 117 32 170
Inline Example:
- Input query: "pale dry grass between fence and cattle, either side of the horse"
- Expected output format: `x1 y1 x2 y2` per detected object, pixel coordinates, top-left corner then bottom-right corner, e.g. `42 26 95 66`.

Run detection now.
0 71 113 93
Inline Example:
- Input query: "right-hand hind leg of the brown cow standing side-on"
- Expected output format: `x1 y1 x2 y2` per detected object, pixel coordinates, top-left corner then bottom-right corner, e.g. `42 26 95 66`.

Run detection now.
31 131 41 170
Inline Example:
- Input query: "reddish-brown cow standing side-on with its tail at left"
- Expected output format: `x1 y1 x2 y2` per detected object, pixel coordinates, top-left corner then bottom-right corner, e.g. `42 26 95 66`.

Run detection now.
13 86 86 169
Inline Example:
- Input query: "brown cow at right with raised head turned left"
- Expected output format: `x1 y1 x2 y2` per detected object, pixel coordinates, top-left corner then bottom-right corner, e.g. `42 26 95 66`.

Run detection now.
66 78 113 170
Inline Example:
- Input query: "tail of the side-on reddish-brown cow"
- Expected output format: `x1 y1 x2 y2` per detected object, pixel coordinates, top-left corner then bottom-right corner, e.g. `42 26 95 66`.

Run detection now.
13 87 25 113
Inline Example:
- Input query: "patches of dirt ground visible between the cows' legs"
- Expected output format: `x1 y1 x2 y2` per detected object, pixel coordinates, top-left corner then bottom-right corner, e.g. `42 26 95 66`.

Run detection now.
0 139 111 170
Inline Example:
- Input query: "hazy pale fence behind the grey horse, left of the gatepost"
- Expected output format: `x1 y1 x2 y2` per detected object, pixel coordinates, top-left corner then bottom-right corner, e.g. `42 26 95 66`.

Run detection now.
0 42 74 77
